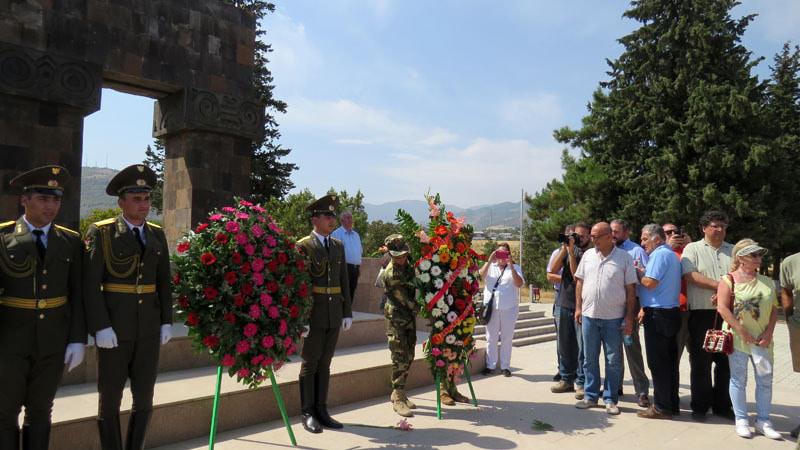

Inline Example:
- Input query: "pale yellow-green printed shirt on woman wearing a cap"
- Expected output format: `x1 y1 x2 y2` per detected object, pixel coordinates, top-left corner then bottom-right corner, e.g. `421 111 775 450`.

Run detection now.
721 275 778 354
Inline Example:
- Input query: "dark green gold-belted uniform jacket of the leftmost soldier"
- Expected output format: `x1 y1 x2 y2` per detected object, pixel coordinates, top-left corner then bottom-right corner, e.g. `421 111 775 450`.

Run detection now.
0 217 86 355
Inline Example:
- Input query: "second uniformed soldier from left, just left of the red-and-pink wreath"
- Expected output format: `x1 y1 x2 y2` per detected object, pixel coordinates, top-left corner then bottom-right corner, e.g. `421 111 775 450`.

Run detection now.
84 164 172 450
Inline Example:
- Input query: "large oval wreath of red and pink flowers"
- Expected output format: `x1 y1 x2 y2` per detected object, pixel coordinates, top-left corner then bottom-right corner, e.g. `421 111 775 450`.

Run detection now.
172 200 311 387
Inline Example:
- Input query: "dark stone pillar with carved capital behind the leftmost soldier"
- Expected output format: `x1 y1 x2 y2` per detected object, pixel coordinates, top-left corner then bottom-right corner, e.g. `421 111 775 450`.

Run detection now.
0 42 102 229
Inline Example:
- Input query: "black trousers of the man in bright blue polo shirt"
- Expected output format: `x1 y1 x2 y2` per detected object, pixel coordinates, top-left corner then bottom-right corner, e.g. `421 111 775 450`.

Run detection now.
644 308 681 414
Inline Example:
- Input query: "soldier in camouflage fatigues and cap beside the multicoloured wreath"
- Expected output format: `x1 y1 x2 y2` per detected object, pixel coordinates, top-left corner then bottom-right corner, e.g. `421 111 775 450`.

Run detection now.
380 234 420 417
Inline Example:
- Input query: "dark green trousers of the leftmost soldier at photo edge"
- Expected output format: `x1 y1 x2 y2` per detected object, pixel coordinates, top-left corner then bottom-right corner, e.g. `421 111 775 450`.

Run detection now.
0 353 64 430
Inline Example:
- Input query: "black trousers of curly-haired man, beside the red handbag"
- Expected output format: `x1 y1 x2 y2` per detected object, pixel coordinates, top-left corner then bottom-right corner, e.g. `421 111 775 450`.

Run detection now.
689 309 731 414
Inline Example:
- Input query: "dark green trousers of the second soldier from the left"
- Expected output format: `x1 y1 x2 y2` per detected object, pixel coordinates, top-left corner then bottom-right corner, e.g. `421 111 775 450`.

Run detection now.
97 335 160 421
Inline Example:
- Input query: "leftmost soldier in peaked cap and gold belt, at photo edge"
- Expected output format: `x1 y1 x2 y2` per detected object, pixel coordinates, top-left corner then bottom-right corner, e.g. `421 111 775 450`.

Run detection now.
0 166 86 450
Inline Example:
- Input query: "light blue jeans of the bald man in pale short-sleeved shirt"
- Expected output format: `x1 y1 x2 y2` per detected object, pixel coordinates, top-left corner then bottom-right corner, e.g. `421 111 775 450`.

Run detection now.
582 316 622 403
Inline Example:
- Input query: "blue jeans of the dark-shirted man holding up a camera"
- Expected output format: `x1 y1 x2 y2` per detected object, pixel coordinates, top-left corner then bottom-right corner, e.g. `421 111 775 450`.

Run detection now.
553 306 585 387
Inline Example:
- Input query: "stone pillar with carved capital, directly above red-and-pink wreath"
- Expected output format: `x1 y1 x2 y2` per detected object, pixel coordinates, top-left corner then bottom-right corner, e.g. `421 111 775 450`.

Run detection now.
153 89 264 244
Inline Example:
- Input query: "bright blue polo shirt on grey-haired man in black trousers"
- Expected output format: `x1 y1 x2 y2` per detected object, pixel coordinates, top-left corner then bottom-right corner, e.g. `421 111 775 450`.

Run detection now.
637 244 681 308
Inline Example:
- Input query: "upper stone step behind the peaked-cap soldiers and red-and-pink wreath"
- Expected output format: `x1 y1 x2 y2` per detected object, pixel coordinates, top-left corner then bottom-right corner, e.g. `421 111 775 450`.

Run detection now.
61 311 386 386
